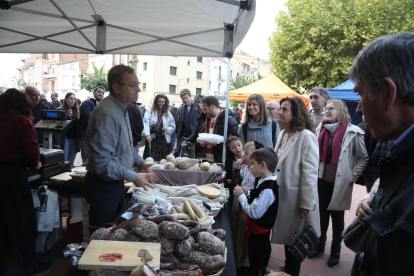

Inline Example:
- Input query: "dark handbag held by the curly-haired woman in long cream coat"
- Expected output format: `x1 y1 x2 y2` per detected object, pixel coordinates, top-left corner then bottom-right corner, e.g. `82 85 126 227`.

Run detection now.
288 214 319 262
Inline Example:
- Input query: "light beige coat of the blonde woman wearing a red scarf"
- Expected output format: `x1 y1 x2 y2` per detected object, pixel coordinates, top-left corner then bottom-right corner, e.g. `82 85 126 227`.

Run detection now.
315 124 368 211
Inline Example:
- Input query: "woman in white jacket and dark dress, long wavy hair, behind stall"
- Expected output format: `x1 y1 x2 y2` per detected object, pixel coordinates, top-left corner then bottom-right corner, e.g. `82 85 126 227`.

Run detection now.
143 94 175 161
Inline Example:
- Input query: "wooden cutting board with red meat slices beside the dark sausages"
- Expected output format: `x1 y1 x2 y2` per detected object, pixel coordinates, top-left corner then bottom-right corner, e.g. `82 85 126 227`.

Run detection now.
78 240 161 271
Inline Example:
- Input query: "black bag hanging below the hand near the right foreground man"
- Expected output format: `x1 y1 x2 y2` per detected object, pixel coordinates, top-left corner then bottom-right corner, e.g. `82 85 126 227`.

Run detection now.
342 218 372 253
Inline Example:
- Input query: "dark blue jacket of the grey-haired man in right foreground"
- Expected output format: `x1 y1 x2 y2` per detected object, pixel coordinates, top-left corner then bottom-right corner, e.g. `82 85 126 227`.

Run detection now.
365 124 414 276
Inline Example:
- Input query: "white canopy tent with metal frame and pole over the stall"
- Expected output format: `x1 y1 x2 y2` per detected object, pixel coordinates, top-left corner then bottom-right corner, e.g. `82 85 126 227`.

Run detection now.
0 0 256 159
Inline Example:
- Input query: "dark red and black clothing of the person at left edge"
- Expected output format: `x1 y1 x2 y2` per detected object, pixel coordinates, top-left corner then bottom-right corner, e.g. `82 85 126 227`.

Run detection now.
0 107 40 253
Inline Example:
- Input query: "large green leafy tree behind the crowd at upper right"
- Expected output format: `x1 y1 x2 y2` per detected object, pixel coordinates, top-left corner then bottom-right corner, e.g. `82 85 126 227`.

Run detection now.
269 0 414 90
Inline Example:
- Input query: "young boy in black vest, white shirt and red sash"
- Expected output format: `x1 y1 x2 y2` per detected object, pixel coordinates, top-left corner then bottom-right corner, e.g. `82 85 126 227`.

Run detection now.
233 148 279 276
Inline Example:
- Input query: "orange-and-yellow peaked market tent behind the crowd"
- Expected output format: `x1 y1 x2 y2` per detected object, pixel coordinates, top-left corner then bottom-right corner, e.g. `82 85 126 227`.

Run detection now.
230 74 310 108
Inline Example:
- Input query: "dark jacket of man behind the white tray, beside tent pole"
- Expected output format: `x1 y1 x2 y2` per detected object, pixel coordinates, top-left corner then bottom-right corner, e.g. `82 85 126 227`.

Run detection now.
203 109 239 163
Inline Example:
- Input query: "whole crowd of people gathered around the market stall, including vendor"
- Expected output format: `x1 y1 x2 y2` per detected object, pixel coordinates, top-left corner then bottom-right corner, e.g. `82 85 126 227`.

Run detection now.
0 34 414 276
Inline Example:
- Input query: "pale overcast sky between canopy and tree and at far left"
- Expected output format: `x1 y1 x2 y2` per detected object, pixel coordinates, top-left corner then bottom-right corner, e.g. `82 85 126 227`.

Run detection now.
0 0 287 85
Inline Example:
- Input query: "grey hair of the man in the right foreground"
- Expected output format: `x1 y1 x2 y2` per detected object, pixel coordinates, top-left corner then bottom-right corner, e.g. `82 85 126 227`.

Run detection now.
349 33 414 105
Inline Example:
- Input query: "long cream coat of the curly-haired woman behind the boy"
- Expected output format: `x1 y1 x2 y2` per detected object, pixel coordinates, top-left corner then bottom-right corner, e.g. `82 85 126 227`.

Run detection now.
272 130 321 244
